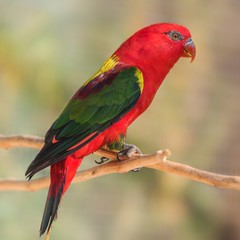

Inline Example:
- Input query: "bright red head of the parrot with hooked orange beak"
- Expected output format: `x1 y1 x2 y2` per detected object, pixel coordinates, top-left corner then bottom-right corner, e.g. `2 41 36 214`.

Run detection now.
116 23 196 70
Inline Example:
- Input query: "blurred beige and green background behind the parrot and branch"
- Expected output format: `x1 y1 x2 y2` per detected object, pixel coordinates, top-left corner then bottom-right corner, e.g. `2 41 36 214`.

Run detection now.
0 0 240 240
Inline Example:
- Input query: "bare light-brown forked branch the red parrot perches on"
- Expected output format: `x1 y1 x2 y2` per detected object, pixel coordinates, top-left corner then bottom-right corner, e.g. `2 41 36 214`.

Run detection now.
0 135 240 191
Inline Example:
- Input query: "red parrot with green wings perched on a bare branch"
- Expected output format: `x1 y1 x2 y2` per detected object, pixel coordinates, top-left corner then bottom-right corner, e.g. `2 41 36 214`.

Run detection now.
26 23 196 235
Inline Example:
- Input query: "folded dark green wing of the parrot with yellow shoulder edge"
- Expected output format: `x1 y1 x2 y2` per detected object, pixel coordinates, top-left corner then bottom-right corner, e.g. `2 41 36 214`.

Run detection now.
26 65 143 178
